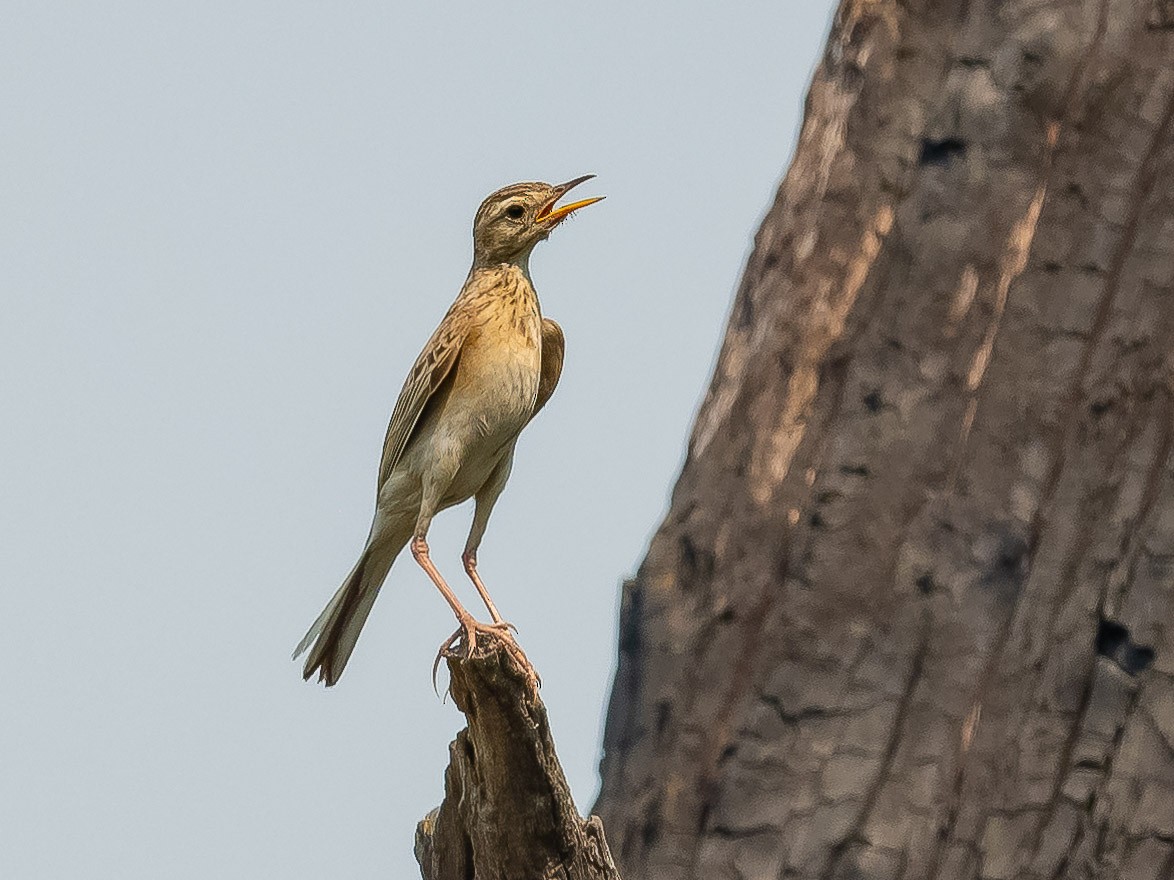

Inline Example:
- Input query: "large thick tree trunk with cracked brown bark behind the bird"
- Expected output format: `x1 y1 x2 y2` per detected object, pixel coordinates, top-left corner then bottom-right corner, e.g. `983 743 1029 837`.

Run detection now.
596 0 1174 880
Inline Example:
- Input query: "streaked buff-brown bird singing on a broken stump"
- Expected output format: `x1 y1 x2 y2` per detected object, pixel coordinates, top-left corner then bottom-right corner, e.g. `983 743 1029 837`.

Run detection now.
294 175 603 688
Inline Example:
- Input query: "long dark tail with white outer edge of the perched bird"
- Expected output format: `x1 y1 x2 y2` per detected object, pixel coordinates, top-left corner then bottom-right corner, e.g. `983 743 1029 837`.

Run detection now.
294 537 407 688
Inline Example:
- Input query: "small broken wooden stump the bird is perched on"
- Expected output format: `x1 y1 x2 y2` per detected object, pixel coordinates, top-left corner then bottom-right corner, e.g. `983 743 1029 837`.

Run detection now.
416 643 620 880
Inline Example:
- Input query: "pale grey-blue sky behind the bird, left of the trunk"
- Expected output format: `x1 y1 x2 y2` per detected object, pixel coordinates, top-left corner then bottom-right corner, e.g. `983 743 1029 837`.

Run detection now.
0 0 831 880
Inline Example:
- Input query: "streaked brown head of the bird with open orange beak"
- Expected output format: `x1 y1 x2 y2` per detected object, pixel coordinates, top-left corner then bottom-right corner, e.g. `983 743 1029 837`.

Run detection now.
473 174 603 265
